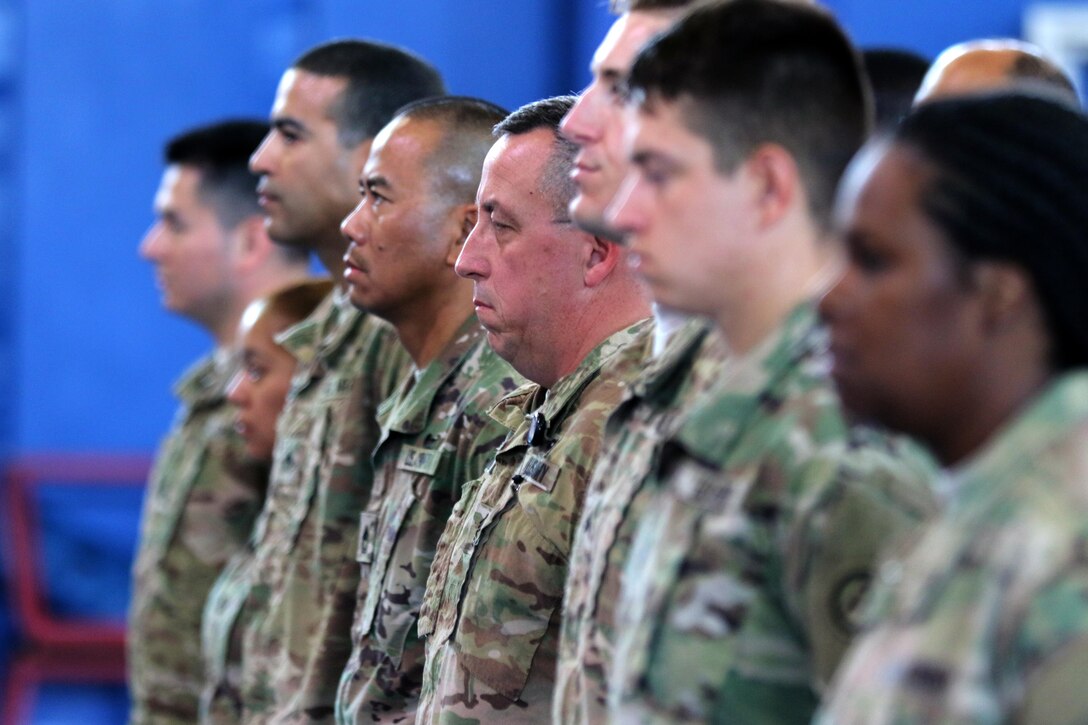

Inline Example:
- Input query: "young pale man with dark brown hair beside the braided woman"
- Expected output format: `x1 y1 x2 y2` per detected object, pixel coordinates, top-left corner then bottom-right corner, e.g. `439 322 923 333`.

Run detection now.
608 0 932 724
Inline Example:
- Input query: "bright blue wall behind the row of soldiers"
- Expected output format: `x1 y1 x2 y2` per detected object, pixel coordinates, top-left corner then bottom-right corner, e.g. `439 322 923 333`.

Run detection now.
0 0 1070 452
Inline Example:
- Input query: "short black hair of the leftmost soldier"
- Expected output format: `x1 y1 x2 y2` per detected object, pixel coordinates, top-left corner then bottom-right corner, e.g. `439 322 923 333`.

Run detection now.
163 119 269 229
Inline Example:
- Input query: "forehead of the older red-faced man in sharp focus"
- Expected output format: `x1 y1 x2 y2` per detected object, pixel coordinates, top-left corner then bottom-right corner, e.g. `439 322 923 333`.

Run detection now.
479 128 555 214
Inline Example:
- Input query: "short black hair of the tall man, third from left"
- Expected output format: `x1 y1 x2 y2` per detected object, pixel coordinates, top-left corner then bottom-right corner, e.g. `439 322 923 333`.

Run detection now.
292 39 446 148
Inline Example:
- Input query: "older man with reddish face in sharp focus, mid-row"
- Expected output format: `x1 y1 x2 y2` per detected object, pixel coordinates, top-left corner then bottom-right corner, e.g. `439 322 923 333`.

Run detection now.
417 97 650 723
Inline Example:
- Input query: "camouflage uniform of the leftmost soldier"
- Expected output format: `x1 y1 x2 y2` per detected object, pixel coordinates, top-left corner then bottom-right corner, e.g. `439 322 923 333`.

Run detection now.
127 351 263 724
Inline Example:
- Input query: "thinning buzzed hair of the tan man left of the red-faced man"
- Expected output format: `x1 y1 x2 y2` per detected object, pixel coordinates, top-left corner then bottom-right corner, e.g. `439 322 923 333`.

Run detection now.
395 96 508 204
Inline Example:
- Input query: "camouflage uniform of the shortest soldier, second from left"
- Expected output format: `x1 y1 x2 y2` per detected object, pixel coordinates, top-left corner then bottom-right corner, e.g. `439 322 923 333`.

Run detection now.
199 546 255 725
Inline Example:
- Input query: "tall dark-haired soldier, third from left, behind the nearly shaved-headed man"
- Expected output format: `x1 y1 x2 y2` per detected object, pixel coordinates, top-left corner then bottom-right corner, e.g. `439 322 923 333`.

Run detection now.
242 40 444 723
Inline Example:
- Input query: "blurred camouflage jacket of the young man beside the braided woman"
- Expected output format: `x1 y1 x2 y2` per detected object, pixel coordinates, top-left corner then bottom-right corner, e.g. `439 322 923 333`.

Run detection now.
608 304 934 725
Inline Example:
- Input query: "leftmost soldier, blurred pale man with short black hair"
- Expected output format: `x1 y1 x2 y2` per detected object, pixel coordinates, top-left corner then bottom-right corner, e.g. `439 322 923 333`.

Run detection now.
127 121 308 723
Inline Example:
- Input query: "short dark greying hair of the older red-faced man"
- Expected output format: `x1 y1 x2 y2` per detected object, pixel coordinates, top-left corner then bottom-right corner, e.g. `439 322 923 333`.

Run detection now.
494 96 578 219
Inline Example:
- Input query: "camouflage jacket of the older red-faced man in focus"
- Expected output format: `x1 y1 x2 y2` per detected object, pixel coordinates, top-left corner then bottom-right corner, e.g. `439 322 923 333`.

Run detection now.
417 320 653 723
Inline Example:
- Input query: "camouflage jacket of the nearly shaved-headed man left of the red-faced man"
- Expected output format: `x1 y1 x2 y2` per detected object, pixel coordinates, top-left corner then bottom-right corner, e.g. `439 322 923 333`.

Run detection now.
336 315 524 724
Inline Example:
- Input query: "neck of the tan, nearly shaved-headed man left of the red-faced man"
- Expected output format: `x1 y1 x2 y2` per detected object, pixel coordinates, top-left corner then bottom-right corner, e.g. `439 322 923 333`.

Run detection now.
390 280 472 363
